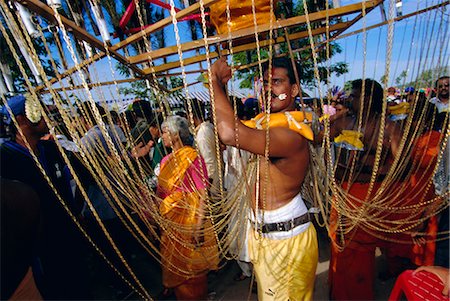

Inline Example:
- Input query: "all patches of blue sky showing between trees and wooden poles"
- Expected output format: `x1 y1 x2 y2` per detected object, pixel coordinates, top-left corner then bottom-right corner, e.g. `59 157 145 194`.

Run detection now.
44 0 449 99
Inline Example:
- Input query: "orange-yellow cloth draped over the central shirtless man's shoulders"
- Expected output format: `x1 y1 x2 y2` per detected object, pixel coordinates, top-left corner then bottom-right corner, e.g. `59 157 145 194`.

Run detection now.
243 111 314 141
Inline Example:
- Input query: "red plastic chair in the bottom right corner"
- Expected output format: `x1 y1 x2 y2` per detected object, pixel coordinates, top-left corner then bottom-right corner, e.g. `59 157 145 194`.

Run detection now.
389 270 450 301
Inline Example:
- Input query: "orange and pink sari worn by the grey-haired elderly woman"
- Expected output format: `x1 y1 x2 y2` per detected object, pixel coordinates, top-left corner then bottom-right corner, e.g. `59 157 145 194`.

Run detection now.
158 146 219 287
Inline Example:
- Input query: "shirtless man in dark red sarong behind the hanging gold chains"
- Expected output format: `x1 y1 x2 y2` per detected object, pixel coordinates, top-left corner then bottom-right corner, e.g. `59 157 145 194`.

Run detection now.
329 79 411 300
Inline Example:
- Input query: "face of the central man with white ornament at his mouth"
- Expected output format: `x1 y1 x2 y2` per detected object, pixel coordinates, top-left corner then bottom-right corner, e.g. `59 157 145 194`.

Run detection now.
264 67 298 113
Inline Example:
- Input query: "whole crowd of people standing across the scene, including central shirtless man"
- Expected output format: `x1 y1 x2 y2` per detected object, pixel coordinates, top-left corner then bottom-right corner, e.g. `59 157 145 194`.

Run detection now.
0 58 450 300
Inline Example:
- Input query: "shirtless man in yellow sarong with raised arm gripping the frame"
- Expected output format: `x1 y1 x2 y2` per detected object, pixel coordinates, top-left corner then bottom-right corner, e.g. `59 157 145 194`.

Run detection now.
211 58 318 300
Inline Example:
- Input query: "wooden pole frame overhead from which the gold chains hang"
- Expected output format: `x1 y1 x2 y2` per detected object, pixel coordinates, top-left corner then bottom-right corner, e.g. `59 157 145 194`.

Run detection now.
18 0 442 93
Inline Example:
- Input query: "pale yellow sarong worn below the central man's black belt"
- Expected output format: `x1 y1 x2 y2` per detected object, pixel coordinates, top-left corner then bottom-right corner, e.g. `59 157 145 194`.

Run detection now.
249 224 318 301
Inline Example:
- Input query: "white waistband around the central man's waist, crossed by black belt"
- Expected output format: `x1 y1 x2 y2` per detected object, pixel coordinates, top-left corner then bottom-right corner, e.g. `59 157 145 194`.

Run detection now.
250 193 310 239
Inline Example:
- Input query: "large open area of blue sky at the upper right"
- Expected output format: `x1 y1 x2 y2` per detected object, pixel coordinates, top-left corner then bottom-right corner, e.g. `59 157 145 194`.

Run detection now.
324 1 449 95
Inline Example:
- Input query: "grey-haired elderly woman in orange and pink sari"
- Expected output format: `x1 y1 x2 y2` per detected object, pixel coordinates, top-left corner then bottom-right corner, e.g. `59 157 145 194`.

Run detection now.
157 116 218 300
